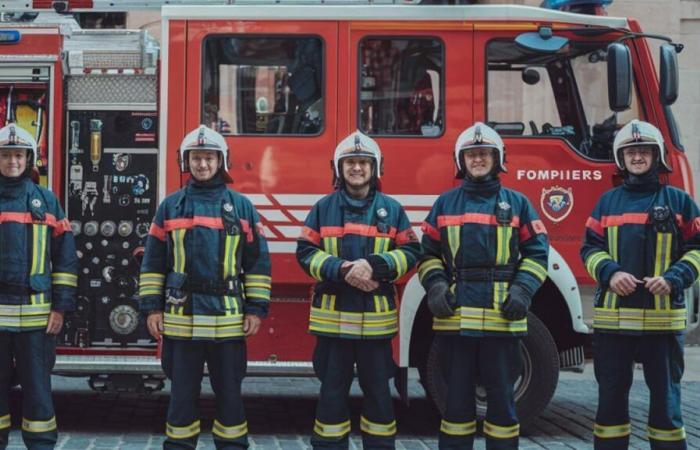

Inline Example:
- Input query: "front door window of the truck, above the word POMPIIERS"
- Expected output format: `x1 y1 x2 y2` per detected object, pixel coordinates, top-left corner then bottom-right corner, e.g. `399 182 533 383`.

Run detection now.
486 40 639 161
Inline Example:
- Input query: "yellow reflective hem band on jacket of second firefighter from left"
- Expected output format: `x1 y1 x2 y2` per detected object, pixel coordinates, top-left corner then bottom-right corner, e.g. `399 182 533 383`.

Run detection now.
163 308 244 339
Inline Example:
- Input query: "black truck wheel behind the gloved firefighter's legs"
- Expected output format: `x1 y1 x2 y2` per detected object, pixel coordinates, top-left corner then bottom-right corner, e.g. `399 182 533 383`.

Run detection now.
425 313 559 427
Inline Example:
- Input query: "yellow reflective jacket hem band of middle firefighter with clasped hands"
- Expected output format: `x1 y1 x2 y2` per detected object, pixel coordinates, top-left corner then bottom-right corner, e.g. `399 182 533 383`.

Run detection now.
309 305 399 337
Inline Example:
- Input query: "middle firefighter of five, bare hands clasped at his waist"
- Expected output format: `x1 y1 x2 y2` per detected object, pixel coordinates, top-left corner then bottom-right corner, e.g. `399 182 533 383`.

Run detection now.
297 131 420 449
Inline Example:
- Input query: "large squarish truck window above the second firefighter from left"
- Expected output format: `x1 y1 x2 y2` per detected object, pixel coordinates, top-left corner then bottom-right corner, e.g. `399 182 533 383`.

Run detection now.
201 36 324 135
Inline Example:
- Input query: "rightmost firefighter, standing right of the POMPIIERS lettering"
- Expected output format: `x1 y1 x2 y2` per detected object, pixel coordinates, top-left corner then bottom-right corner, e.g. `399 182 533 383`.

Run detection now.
581 120 700 450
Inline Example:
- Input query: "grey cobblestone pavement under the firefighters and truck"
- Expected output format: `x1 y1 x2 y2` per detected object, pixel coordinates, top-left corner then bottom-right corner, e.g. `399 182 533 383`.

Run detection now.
8 356 700 450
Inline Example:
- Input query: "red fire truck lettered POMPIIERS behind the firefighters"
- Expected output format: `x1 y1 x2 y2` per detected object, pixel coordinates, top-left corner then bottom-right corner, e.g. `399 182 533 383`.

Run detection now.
0 0 697 422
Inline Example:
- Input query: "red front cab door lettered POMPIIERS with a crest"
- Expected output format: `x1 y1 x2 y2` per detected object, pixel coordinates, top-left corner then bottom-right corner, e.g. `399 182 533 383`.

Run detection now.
474 29 644 284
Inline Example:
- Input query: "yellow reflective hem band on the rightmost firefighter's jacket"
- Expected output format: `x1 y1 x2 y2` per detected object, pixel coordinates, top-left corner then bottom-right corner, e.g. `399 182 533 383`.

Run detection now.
593 308 686 331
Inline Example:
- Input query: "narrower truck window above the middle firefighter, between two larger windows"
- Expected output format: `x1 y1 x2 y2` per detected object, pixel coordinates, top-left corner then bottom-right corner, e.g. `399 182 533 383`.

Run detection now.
358 37 445 136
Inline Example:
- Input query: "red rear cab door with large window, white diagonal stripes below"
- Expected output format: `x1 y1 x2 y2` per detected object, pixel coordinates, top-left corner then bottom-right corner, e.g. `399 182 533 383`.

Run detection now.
185 18 338 362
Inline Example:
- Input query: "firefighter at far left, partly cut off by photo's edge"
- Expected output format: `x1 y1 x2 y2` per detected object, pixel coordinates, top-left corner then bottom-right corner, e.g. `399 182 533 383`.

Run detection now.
0 124 78 450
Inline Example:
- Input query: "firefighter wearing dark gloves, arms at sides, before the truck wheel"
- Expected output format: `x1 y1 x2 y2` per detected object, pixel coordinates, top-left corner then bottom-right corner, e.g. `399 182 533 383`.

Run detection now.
418 122 548 450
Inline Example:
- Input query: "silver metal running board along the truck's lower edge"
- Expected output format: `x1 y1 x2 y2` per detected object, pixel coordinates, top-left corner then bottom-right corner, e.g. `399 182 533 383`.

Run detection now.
53 355 314 377
